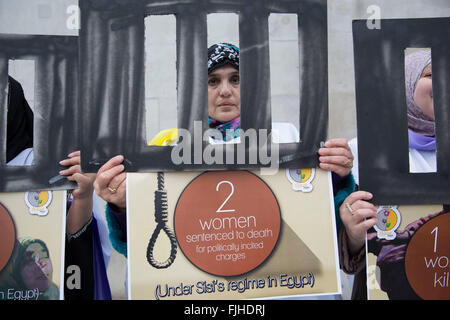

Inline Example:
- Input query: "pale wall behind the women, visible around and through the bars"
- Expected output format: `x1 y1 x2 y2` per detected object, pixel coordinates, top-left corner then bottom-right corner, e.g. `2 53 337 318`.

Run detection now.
0 0 450 299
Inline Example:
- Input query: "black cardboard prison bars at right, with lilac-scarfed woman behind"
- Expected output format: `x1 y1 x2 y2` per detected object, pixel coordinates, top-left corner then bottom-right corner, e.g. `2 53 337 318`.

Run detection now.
353 18 450 205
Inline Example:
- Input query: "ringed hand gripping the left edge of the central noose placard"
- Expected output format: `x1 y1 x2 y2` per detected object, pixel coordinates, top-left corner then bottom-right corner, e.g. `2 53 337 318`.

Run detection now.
94 155 127 211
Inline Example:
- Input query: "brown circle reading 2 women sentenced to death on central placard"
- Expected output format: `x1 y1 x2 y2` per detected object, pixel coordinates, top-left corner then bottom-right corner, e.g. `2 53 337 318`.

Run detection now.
174 171 281 276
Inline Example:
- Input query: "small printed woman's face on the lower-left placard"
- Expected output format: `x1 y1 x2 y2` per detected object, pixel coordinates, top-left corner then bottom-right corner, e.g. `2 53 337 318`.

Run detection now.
21 243 53 291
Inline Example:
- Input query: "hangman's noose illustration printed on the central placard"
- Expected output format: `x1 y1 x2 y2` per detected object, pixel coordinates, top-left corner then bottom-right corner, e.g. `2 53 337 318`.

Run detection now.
147 172 177 269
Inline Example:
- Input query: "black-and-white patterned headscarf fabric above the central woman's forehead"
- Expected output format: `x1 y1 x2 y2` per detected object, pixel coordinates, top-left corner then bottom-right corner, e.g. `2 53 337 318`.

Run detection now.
208 43 239 74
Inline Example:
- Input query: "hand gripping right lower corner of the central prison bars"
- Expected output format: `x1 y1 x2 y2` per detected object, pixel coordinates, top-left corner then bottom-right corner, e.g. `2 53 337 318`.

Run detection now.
319 138 354 177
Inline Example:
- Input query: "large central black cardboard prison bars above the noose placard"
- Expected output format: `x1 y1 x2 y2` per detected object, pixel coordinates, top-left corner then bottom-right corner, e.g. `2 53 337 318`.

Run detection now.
80 0 328 172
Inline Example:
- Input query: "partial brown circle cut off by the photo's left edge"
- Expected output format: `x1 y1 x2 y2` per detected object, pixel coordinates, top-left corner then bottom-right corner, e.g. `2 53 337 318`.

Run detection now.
0 204 16 271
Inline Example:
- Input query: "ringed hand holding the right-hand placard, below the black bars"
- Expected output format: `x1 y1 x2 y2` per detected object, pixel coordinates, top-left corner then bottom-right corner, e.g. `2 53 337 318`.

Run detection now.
339 191 378 255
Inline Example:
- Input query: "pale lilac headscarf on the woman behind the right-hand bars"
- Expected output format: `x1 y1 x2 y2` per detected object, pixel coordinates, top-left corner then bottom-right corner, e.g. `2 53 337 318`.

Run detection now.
405 49 435 137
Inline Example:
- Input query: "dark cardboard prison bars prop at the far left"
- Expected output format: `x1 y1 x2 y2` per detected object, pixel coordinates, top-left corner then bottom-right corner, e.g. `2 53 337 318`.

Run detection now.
0 34 80 192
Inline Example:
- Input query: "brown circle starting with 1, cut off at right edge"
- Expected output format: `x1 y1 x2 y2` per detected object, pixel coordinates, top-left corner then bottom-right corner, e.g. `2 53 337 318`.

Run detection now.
405 213 450 300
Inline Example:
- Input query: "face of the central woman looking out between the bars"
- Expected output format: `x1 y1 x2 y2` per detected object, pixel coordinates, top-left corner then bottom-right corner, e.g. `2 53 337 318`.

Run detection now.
208 65 241 122
